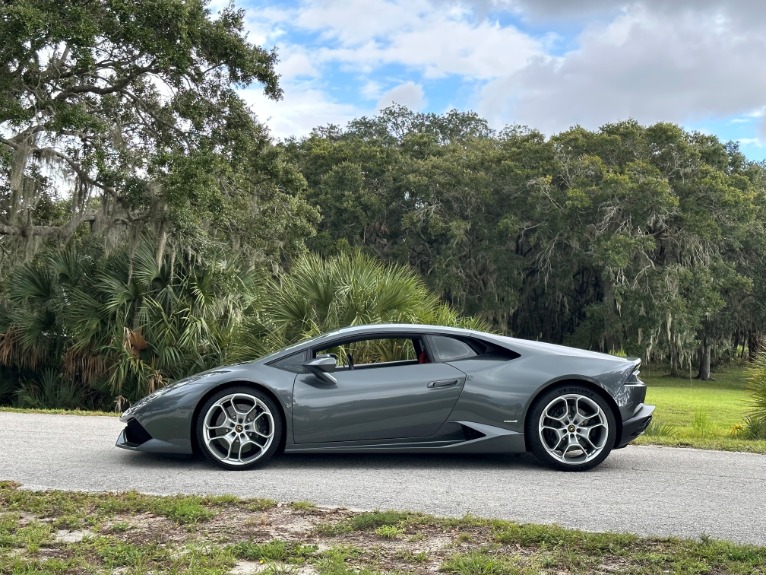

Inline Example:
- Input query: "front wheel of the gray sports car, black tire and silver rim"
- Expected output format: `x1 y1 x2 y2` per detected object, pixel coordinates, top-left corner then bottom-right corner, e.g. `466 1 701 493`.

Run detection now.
195 386 284 471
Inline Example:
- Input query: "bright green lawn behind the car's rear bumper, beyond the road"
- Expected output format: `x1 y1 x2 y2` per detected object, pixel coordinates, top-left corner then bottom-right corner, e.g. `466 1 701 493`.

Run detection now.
638 366 766 453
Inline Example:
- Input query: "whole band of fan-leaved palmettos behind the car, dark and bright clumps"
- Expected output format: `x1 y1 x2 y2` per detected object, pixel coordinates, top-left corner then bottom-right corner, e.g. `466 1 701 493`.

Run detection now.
0 241 483 410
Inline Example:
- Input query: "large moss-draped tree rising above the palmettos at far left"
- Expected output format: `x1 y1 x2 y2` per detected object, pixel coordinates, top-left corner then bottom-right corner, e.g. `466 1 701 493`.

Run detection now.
0 0 316 269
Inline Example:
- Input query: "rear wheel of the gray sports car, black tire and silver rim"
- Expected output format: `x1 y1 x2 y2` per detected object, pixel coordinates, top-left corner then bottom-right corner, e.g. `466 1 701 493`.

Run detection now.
525 385 617 471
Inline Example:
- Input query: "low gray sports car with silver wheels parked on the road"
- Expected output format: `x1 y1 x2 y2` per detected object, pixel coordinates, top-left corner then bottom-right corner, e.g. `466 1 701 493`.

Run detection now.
117 324 654 471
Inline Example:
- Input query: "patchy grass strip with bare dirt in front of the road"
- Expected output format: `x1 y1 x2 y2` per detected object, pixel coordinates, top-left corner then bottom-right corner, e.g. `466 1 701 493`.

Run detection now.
0 481 766 575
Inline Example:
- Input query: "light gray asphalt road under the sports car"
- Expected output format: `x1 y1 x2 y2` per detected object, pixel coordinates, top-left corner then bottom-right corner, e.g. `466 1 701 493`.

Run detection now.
0 412 766 546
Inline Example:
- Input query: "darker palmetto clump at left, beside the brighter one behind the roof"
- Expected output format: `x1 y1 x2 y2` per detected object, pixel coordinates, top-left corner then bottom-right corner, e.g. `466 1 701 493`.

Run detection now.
0 239 260 409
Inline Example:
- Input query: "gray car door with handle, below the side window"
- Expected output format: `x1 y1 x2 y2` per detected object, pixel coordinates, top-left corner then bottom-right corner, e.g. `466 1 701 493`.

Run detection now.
293 338 466 444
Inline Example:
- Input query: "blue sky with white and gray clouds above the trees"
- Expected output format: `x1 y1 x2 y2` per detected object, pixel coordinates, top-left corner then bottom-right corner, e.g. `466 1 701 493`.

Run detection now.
222 0 766 160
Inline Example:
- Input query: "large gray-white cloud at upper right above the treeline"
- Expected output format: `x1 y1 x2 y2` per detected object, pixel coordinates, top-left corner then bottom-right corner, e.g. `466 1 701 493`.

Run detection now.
478 3 766 132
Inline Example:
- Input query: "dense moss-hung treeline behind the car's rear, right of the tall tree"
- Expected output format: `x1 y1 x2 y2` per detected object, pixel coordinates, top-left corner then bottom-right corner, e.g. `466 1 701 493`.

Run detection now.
285 107 766 379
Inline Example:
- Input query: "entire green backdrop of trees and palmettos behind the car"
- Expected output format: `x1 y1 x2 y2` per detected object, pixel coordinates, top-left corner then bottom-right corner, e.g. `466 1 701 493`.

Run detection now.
0 0 766 408
